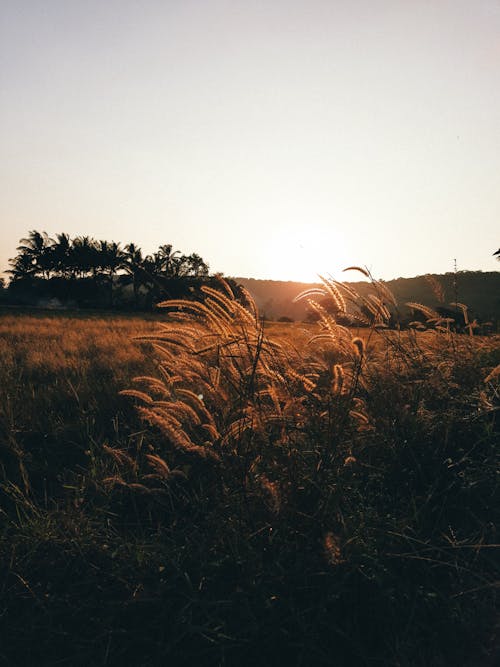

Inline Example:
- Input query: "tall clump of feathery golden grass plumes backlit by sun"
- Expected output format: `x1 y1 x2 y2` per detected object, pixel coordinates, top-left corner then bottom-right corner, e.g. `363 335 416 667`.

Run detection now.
113 279 498 500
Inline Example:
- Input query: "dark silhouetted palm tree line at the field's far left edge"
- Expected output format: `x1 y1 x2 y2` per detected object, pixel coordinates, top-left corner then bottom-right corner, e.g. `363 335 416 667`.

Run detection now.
2 230 236 310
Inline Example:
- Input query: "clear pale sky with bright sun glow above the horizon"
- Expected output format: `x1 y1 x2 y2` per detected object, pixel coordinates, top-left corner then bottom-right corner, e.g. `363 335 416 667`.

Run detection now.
0 0 500 280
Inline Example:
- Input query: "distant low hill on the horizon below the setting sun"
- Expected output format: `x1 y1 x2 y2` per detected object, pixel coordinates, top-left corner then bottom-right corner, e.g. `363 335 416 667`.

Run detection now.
235 271 500 322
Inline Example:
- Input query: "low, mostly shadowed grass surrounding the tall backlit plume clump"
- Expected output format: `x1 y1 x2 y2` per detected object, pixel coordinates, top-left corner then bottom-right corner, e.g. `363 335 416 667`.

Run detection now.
0 315 500 667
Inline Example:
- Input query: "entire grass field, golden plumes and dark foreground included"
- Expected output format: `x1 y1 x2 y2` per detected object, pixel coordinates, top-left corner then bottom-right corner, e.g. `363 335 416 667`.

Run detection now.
0 284 500 667
